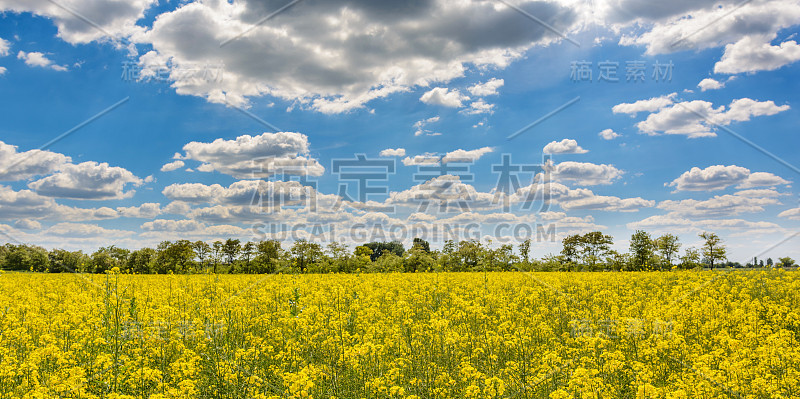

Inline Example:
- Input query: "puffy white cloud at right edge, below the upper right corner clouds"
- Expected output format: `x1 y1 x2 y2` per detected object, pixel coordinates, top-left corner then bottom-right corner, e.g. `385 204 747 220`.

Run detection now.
714 37 800 74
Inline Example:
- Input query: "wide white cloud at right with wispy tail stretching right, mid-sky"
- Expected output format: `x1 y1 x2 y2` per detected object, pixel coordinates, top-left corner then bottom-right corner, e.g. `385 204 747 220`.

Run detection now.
636 98 789 138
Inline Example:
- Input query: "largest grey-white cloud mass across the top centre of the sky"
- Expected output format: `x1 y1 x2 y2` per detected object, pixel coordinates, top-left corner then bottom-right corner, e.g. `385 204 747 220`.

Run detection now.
134 0 577 113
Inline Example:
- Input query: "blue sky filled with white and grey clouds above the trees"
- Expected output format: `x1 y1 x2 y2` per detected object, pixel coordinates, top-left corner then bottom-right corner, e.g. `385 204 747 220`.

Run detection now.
0 0 800 261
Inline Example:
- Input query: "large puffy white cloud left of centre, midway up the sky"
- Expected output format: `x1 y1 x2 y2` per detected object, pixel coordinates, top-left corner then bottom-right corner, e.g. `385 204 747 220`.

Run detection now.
182 132 325 179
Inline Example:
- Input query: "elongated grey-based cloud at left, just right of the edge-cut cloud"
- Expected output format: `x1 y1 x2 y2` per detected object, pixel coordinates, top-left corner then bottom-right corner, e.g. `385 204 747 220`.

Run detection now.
28 161 144 200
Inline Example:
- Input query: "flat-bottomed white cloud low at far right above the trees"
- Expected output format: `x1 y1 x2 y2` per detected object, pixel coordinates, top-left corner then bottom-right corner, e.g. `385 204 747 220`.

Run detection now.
669 165 789 191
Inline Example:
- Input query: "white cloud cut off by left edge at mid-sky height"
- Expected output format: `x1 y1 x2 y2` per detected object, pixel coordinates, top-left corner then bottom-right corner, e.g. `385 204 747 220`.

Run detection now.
0 141 72 181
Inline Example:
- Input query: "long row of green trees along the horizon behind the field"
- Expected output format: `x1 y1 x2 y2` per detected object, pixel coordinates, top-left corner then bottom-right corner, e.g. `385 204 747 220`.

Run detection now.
0 230 796 274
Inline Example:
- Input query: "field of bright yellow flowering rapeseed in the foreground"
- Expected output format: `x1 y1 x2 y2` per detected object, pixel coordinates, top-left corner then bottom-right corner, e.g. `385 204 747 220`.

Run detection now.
0 270 800 398
